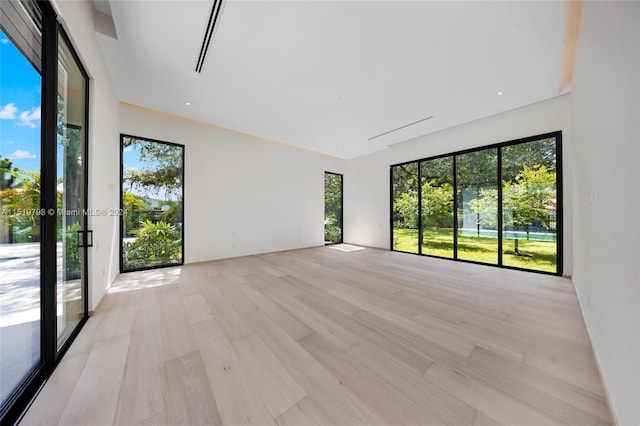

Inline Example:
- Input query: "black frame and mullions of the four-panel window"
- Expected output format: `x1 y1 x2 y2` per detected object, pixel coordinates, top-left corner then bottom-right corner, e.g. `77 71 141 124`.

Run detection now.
389 130 564 276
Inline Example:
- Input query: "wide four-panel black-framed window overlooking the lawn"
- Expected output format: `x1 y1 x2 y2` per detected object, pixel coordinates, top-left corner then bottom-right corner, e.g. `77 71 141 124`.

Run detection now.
391 132 562 274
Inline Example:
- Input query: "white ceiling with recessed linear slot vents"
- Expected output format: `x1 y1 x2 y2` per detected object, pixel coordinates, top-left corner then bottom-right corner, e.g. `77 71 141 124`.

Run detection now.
96 0 565 158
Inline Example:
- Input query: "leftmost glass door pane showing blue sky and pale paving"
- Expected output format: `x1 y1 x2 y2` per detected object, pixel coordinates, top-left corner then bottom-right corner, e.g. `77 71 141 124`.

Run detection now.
0 29 42 405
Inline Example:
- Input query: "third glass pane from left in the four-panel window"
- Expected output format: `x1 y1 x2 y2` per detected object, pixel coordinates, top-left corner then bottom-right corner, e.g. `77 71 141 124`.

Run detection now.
456 148 498 264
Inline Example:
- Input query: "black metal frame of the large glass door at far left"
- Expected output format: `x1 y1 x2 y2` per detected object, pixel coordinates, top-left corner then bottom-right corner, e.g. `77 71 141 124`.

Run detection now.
0 0 90 424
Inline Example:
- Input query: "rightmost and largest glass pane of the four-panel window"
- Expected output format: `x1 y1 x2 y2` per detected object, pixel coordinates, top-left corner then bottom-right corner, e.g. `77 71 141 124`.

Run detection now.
502 138 557 273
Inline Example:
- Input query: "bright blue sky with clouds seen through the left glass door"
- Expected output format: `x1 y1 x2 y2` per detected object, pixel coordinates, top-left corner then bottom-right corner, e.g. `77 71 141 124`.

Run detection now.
0 31 41 171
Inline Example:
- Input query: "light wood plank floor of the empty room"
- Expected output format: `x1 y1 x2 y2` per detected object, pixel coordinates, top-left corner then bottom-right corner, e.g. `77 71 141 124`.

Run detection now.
22 247 611 426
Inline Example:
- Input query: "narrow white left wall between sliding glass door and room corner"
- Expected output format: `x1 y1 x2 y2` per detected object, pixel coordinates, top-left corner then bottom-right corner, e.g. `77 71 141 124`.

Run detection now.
55 1 120 310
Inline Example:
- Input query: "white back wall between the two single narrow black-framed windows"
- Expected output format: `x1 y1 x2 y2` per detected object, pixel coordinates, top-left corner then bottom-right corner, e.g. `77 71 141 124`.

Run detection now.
120 104 344 263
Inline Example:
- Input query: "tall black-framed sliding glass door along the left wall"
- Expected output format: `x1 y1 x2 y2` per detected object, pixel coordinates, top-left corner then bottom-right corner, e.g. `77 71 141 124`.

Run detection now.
0 0 89 424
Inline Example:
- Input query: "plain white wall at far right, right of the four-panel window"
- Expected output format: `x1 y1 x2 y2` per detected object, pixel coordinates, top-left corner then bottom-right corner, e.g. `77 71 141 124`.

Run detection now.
572 2 640 425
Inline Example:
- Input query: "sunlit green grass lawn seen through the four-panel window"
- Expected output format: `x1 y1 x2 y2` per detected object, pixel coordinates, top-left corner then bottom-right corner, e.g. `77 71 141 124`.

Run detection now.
393 229 556 272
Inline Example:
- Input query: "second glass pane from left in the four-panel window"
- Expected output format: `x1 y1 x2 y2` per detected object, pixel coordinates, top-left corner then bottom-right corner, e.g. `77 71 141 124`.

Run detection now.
420 157 453 258
